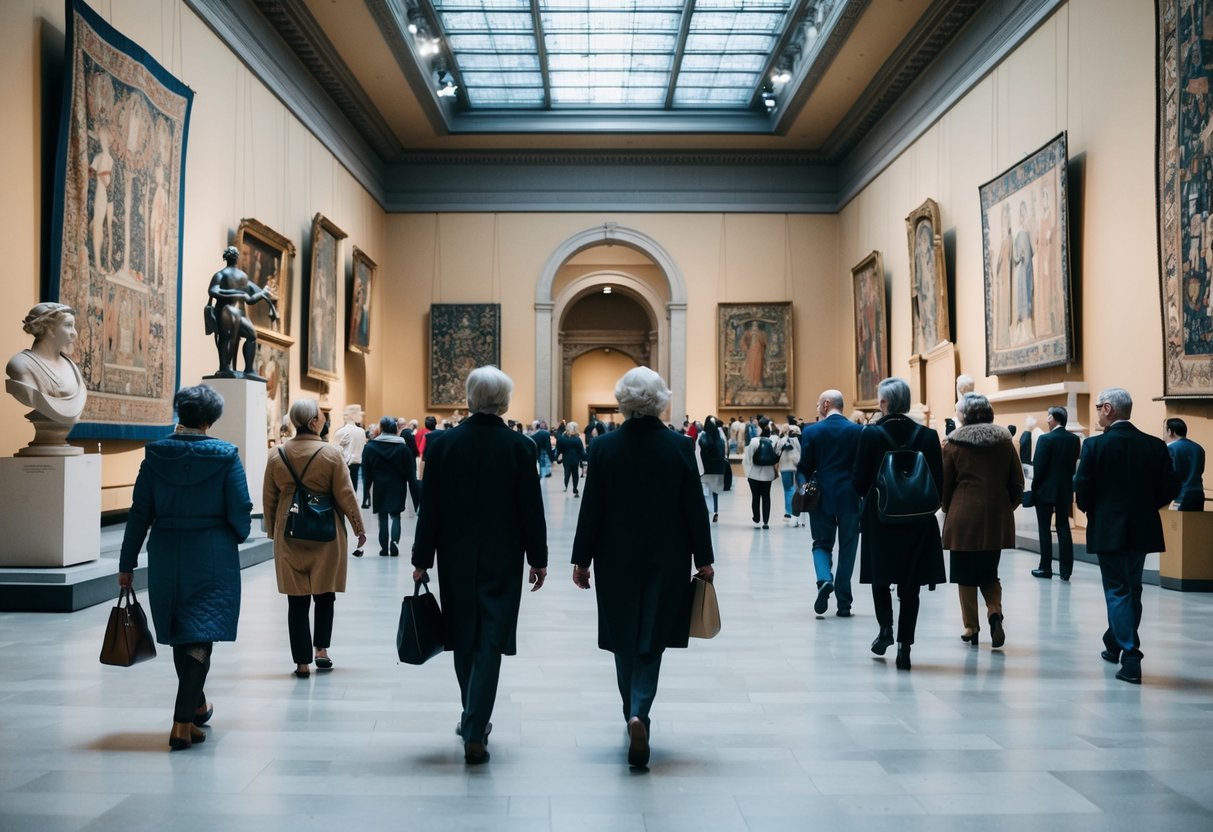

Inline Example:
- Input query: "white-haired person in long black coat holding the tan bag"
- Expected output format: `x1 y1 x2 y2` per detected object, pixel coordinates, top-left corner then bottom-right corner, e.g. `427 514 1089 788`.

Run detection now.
573 366 714 768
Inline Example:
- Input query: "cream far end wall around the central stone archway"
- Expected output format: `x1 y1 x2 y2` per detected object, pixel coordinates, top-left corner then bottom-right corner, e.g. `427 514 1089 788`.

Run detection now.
383 213 839 429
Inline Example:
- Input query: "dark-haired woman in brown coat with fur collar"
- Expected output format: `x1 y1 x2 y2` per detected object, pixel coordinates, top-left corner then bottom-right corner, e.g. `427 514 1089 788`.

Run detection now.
941 393 1024 648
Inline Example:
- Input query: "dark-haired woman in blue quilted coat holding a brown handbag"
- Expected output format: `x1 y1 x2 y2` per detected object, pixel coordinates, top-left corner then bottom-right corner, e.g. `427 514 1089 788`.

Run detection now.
118 384 252 751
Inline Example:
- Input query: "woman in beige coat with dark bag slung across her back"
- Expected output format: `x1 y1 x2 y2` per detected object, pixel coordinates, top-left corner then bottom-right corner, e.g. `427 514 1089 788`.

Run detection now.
269 399 366 679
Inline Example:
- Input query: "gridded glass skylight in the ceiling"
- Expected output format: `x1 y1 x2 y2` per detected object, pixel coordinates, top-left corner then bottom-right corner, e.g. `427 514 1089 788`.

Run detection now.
417 0 797 110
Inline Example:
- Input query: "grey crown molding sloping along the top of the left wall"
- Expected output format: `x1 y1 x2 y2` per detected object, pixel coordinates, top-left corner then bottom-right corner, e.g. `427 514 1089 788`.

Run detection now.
186 0 385 205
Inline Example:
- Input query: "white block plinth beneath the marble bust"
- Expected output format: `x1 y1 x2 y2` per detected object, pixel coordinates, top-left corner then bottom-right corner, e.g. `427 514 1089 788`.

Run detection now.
0 454 101 566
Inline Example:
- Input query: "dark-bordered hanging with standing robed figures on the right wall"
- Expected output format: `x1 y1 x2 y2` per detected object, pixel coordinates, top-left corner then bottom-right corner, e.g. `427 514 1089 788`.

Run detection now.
978 132 1075 375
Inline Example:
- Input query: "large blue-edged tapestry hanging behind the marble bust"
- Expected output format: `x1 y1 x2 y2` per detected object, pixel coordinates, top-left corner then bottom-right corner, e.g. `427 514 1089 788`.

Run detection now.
50 0 194 439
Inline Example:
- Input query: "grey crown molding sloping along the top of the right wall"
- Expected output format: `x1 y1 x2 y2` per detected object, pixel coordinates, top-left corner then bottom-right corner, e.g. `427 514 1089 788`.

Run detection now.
837 0 1066 210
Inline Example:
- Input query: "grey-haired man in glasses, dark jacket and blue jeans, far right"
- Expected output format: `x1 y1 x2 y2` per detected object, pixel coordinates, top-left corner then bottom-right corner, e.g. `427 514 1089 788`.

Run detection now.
1074 387 1179 684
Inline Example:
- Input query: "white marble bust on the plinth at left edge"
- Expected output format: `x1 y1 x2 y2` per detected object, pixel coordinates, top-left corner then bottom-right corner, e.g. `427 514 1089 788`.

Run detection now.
5 303 89 456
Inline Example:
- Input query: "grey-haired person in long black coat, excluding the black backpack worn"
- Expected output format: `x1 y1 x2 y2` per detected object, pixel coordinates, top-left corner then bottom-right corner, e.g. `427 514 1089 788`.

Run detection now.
852 377 947 671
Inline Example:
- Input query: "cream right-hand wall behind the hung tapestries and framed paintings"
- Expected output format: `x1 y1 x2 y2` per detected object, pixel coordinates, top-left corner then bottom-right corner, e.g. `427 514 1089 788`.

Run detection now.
836 0 1193 444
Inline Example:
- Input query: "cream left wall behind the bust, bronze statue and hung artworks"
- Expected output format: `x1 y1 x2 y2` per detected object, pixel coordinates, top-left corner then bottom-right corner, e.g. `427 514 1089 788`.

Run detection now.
0 0 389 509
